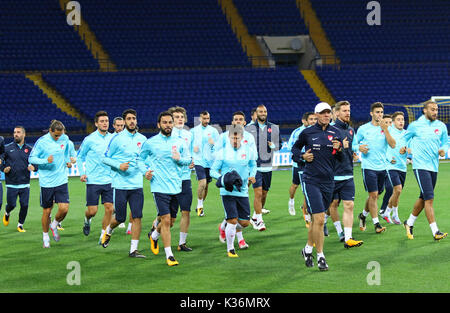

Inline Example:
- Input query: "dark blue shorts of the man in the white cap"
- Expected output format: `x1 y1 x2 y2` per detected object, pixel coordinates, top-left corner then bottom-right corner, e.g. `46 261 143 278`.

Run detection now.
303 181 334 214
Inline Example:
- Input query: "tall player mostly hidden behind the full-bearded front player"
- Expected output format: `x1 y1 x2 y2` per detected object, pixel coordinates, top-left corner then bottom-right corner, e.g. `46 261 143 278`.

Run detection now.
168 106 193 252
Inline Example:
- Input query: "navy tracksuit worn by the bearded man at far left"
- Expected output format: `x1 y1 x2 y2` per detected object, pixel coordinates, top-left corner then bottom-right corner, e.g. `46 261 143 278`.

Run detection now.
0 142 37 224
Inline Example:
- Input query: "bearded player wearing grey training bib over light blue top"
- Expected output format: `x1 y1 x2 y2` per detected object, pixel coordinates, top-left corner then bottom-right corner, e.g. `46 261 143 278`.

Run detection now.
245 104 282 231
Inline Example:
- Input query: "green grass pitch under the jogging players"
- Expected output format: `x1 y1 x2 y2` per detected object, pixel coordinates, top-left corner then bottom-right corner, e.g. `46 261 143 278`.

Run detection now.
0 164 450 293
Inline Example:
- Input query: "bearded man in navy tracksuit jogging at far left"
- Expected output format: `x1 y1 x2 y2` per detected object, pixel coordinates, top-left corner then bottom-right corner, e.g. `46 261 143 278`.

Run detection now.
0 126 37 233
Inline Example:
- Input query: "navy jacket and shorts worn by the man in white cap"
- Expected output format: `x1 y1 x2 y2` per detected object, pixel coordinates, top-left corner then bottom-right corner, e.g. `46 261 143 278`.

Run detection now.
291 123 343 214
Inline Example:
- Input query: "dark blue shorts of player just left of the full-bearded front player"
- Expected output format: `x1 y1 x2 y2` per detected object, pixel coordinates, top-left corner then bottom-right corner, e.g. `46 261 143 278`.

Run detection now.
113 188 144 223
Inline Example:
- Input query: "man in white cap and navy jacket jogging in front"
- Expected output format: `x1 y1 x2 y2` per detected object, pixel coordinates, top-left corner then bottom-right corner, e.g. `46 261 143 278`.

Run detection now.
292 102 343 271
